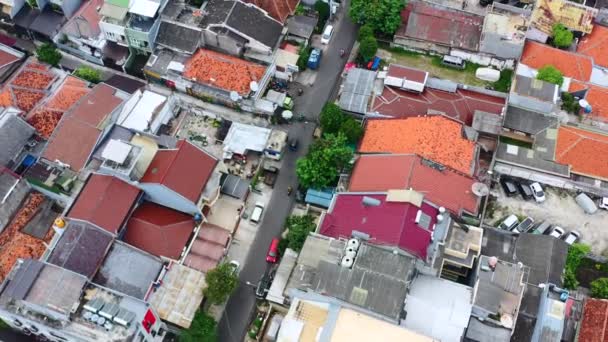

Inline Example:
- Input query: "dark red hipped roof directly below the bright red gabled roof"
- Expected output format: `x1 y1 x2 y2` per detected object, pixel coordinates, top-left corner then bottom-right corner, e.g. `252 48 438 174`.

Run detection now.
124 202 195 260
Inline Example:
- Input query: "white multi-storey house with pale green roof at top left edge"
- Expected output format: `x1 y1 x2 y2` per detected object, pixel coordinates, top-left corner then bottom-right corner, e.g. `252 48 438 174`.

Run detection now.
99 0 167 54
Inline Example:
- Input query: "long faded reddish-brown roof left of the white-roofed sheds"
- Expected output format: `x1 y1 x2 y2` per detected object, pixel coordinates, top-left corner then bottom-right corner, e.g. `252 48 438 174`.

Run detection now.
42 84 123 171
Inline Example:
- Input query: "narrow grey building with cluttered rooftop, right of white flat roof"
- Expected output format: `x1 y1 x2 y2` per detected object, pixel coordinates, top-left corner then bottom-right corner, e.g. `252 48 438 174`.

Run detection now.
466 255 530 342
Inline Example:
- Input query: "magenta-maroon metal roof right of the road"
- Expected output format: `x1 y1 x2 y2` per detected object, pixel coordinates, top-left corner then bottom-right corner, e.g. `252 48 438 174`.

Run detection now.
320 193 439 259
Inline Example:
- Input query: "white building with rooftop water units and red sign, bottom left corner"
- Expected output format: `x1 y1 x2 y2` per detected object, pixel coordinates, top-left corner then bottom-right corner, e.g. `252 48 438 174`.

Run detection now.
0 259 166 342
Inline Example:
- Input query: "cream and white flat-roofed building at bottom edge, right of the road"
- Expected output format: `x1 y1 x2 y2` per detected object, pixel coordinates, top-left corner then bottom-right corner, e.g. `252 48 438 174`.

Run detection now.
277 291 435 342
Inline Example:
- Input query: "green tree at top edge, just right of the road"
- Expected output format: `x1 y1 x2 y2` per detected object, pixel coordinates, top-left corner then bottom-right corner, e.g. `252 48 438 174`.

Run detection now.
348 0 405 35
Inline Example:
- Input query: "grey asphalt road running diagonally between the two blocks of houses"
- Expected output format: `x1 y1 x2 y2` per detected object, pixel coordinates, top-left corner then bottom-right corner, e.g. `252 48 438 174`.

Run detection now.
218 2 357 342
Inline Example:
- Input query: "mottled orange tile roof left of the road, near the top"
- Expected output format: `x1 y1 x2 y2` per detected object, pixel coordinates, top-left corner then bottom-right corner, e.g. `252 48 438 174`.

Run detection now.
184 49 266 95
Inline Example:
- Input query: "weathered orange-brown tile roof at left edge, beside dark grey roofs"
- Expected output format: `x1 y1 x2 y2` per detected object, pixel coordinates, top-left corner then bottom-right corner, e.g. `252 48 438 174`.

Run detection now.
0 192 54 282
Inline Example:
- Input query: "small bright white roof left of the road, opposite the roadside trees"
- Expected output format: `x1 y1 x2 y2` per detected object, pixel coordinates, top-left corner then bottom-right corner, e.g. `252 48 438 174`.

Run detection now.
224 122 271 158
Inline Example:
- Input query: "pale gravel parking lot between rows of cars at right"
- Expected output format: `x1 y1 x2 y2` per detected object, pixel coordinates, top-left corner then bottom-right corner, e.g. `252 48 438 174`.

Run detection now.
485 185 608 253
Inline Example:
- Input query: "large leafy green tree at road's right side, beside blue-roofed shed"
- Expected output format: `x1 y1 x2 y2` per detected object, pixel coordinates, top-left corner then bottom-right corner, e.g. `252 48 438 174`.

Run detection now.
296 134 353 188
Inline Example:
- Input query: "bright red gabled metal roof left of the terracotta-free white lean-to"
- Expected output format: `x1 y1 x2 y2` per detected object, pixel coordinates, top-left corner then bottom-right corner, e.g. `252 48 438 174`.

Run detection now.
141 140 217 202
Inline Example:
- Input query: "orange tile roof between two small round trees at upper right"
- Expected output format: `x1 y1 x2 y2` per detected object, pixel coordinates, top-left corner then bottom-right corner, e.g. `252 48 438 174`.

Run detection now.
520 40 593 82
